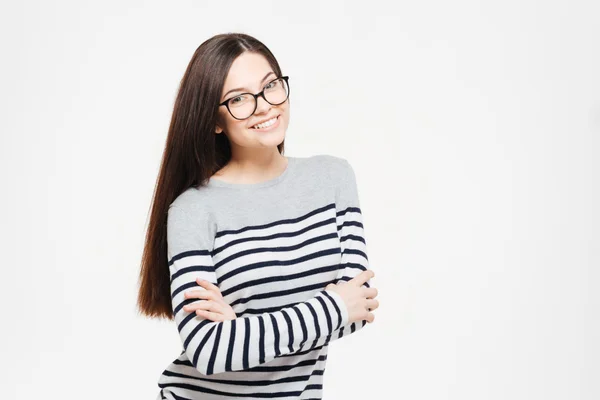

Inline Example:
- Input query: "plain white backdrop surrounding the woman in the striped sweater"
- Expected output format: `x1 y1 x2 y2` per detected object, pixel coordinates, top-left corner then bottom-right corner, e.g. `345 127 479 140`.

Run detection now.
0 0 600 400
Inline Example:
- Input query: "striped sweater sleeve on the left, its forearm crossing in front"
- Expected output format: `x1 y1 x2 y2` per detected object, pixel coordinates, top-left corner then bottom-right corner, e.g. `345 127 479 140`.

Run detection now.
167 205 348 375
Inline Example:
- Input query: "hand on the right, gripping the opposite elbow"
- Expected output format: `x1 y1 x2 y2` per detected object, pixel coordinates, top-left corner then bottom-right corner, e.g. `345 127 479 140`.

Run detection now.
325 269 379 323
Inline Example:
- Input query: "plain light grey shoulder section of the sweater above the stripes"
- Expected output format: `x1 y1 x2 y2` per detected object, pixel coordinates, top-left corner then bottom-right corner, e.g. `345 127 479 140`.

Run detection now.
170 154 359 244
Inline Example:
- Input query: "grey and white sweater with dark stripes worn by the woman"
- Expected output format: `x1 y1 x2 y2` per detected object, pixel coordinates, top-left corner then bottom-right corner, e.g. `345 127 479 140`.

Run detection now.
157 154 369 400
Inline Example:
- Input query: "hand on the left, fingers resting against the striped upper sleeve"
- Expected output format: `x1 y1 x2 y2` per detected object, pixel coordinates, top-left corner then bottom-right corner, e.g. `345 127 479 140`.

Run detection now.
183 278 237 322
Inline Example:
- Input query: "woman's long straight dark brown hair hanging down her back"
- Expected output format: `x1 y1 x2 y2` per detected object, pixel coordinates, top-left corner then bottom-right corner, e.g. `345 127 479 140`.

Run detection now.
137 33 284 319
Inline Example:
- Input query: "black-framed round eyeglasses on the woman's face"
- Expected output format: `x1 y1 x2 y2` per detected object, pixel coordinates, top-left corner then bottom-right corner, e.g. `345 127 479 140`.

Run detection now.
219 76 290 120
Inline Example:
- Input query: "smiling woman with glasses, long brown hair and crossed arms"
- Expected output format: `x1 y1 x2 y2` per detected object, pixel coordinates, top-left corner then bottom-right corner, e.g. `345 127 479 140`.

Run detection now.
138 34 379 399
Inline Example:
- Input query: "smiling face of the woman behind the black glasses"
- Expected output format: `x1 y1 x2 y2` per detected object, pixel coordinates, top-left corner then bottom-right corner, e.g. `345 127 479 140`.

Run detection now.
215 52 290 153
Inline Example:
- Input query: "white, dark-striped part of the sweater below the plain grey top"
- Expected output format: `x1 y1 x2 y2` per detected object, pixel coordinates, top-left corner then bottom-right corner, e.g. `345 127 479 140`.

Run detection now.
158 158 369 399
